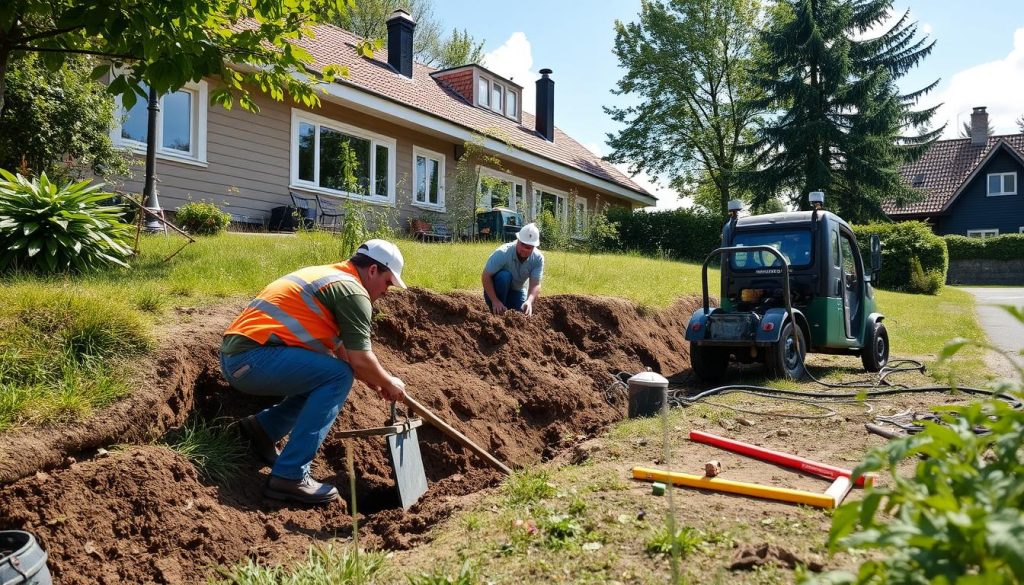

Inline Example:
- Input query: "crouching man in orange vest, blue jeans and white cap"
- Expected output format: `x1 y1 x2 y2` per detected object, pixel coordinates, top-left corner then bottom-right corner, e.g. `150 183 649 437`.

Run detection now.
220 240 406 504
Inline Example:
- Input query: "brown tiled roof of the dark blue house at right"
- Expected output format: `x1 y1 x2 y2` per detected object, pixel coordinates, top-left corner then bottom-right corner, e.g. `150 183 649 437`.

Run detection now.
883 134 1024 216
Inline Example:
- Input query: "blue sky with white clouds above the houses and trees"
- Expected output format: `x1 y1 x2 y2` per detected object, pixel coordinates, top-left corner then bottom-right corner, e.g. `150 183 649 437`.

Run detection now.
434 0 1024 208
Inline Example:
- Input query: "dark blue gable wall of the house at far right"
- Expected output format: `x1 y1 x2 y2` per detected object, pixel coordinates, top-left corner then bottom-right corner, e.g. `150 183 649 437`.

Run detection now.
935 151 1024 236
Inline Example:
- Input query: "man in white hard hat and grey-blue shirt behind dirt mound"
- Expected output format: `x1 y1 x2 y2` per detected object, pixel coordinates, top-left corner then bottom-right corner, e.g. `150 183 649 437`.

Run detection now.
480 223 544 316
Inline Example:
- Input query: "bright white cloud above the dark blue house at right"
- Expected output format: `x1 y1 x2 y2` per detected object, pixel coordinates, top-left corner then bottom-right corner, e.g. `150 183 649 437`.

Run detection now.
929 28 1024 138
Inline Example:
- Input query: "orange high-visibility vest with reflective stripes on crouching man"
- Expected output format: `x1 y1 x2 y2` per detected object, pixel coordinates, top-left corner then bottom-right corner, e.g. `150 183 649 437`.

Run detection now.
224 261 362 354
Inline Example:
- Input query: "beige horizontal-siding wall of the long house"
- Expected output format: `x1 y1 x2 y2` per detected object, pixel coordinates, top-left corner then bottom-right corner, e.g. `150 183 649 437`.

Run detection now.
116 81 632 231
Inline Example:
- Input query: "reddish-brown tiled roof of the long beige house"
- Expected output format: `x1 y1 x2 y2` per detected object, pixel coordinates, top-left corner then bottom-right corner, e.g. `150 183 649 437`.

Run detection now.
298 25 654 205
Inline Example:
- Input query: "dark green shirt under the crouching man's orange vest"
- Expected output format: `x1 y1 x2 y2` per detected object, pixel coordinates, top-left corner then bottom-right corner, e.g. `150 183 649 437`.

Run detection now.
220 280 373 356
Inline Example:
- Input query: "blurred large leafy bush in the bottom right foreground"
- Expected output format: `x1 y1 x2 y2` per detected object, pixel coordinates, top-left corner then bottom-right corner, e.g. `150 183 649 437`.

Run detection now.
818 307 1024 585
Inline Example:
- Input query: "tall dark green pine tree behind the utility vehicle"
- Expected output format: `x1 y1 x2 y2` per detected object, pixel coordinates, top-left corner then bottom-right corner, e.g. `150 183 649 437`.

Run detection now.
746 0 945 221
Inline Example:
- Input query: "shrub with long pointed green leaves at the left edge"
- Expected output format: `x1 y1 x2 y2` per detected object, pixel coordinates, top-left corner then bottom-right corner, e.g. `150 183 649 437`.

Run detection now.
0 169 132 273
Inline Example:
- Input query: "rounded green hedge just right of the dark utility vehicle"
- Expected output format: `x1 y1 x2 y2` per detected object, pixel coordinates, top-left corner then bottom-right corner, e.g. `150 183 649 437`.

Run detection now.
853 221 949 294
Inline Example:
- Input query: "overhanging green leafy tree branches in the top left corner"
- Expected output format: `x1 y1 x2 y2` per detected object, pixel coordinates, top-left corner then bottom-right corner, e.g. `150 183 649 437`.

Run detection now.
0 0 351 118
